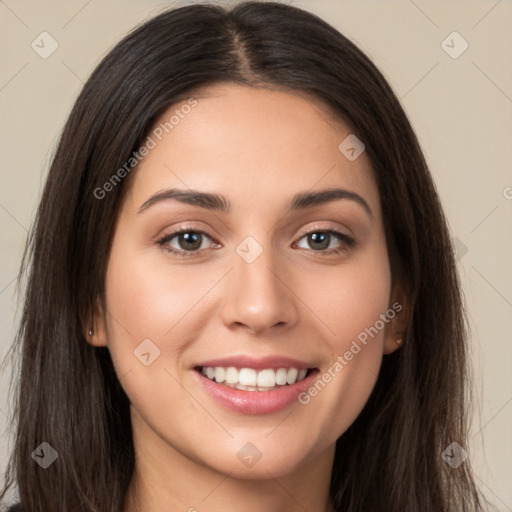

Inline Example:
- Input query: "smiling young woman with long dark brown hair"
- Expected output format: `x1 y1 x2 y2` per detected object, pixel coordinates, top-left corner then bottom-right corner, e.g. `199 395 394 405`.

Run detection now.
1 2 483 512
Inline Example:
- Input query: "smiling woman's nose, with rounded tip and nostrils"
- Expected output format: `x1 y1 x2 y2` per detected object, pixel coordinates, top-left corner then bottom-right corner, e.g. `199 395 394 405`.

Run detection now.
222 242 298 334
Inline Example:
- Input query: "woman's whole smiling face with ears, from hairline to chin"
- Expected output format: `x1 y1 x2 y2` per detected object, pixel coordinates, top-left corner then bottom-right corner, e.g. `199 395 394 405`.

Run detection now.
91 84 404 478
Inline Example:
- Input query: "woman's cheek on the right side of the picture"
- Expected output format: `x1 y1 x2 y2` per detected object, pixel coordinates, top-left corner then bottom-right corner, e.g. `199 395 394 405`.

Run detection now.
299 247 394 445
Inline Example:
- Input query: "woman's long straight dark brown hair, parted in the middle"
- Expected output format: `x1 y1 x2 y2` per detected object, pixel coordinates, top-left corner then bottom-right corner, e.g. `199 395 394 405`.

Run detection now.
0 2 483 512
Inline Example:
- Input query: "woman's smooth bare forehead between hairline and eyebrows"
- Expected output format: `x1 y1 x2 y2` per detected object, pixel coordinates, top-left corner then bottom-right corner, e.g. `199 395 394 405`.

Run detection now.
123 84 379 218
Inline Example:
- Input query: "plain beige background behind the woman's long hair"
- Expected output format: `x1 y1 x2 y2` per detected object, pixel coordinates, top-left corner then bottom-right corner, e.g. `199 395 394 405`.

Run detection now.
0 0 512 511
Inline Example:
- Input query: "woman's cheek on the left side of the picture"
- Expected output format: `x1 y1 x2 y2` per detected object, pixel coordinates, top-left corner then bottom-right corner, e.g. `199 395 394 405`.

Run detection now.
101 243 214 435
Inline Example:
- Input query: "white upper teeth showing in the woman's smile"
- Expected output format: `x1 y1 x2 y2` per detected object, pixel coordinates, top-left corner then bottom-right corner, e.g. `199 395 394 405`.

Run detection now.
201 366 307 391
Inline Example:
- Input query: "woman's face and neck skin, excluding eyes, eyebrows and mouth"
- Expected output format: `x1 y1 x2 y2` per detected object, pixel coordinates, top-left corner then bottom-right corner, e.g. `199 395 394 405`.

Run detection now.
90 84 407 512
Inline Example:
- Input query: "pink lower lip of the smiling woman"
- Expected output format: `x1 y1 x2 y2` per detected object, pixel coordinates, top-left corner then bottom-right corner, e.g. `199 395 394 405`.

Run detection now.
194 370 317 414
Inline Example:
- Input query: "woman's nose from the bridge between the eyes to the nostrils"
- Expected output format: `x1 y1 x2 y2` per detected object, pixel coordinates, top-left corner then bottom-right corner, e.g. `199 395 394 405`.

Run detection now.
223 236 296 331
